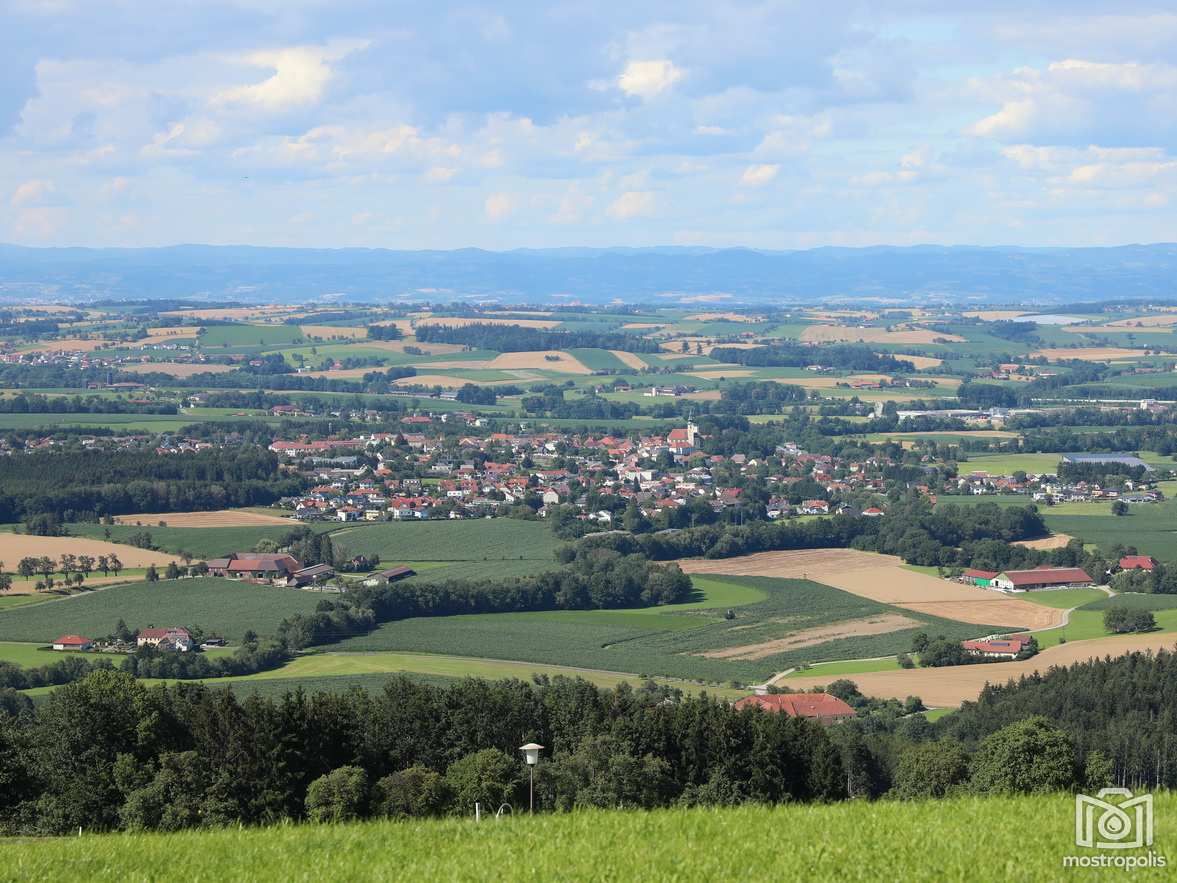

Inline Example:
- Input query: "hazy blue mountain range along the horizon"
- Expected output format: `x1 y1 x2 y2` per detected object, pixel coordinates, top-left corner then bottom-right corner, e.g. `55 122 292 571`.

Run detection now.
0 244 1177 306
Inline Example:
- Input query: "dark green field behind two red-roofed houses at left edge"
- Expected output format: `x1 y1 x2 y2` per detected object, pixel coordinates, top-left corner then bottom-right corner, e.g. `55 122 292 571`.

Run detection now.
0 577 324 642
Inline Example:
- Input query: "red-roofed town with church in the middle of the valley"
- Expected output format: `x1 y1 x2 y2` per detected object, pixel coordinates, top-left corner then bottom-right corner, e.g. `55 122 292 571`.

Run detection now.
270 416 899 524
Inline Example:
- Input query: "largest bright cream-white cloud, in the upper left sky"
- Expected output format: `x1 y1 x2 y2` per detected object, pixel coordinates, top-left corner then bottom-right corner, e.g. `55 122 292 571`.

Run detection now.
212 40 368 112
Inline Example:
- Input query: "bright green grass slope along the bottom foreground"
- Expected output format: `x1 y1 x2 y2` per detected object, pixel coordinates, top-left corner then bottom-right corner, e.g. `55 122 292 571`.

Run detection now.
0 792 1177 883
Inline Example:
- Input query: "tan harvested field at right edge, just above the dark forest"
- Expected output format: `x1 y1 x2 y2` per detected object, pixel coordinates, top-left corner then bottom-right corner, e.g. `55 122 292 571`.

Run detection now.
782 635 1177 708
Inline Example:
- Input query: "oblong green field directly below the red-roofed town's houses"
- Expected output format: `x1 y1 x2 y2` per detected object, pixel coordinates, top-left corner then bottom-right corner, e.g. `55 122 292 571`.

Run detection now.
332 518 560 562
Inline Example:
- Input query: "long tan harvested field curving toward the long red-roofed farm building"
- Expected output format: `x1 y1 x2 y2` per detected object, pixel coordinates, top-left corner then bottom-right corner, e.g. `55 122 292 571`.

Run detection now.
679 549 1064 629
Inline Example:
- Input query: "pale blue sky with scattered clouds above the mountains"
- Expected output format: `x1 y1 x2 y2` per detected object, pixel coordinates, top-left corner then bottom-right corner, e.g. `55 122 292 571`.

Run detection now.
0 0 1177 250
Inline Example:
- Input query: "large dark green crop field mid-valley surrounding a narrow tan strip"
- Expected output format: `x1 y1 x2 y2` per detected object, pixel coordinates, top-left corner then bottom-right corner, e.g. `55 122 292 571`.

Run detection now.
338 577 998 683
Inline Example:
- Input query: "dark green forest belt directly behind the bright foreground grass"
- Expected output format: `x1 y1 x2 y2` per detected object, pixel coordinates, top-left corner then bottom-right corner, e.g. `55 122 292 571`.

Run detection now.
0 655 1144 834
